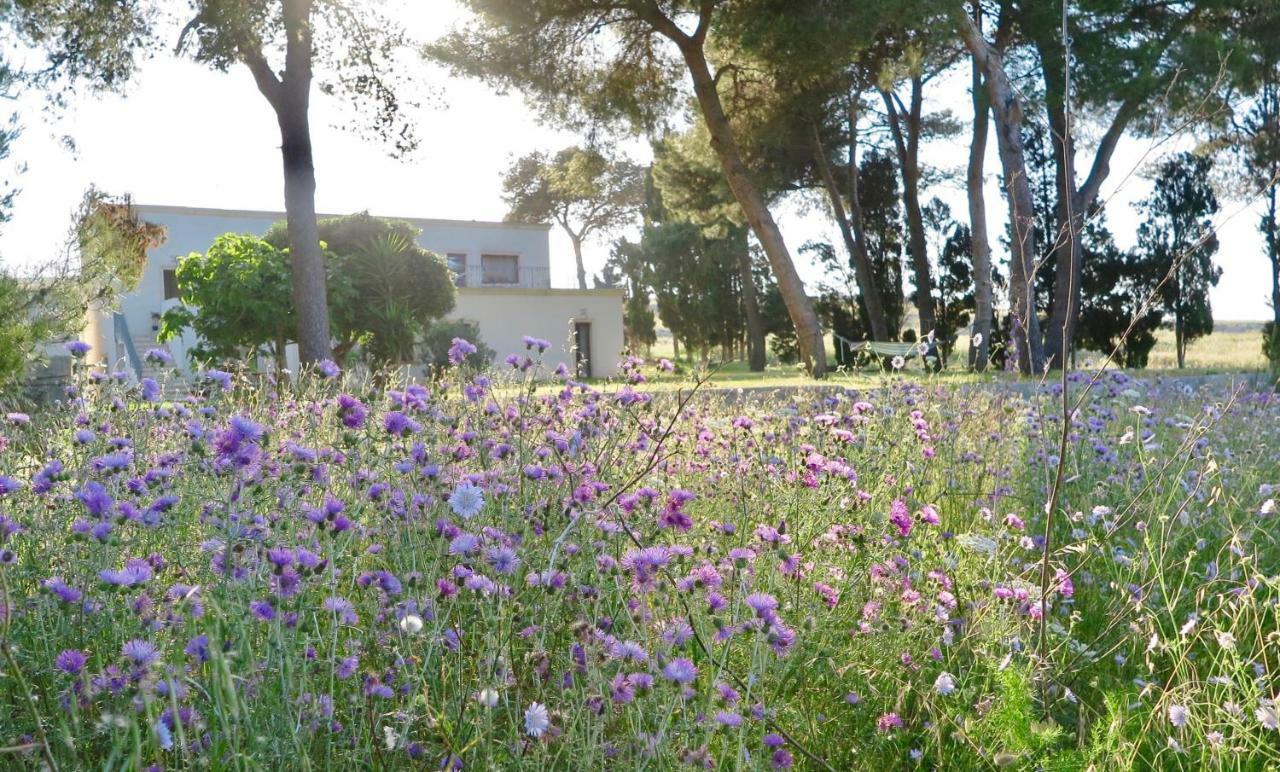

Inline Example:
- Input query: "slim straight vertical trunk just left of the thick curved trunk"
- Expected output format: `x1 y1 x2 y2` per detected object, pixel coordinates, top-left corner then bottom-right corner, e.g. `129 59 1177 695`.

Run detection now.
965 23 995 373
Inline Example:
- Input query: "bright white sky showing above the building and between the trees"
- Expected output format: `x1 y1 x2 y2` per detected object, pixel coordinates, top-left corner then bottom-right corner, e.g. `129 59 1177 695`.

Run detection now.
0 0 1270 320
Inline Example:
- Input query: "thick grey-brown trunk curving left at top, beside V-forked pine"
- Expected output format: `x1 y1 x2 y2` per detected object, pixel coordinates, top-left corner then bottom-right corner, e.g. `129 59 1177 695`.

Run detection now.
960 12 1044 374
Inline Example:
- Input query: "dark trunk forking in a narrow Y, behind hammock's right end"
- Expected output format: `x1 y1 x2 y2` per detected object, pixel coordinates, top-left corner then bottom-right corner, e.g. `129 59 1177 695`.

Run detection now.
879 74 937 339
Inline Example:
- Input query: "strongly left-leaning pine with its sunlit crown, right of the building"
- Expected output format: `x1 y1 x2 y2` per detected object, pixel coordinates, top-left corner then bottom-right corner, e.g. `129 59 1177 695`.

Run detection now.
428 0 827 378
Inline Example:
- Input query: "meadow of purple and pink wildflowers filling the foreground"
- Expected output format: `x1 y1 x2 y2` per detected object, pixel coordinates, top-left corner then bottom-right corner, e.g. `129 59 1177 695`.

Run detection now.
0 341 1280 769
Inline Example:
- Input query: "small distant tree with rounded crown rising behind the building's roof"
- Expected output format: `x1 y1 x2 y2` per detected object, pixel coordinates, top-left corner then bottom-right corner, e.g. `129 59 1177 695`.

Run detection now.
502 147 645 289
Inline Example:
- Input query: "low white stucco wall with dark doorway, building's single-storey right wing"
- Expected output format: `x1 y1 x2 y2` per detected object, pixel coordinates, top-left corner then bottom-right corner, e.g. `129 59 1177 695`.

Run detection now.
449 288 623 378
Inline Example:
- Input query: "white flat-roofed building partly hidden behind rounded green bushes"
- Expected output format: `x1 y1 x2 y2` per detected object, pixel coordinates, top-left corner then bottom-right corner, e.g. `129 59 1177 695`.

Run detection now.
86 205 623 378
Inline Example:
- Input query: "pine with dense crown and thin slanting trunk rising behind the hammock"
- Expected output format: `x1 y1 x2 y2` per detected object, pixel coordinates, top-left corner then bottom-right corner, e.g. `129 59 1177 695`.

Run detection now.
717 0 901 341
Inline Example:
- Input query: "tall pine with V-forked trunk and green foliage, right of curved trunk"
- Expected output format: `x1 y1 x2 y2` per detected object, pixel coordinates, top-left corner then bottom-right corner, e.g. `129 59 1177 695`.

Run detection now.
1004 0 1251 367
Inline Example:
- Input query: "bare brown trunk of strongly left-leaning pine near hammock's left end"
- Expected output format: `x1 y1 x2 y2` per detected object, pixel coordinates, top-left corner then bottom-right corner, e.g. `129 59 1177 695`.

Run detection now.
676 36 827 378
